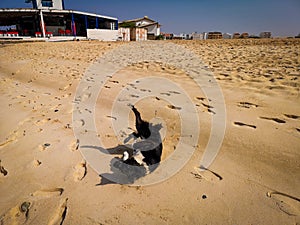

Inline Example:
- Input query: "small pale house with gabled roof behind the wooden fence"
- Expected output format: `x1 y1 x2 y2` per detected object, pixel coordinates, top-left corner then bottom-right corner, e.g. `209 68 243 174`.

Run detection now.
119 16 161 40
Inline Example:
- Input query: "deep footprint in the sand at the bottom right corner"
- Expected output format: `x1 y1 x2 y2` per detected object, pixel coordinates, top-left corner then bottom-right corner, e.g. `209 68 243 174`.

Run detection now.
267 191 300 216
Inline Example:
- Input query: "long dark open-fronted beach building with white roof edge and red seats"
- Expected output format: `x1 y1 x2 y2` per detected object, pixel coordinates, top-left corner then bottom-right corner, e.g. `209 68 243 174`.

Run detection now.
0 0 118 40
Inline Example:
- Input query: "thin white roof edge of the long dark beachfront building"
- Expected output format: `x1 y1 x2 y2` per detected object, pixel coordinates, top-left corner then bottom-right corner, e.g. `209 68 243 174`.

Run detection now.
0 8 118 20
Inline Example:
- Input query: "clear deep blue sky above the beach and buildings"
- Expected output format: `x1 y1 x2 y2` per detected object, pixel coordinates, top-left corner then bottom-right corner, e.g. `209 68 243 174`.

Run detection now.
0 0 300 36
